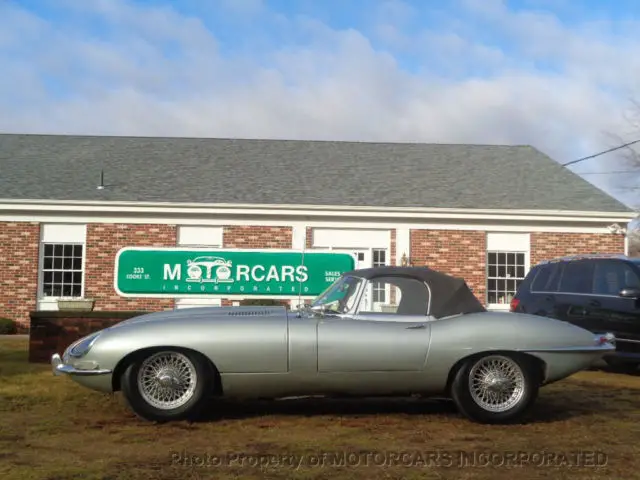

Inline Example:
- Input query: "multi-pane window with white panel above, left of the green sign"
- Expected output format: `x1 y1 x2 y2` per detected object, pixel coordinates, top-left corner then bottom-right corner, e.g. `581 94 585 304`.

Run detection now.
38 224 86 303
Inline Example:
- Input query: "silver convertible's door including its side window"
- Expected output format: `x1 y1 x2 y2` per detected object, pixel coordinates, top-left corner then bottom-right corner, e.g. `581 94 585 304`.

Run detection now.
317 277 431 373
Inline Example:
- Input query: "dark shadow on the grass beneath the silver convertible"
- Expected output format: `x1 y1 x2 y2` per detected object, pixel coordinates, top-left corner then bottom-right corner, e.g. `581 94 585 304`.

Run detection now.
190 398 597 423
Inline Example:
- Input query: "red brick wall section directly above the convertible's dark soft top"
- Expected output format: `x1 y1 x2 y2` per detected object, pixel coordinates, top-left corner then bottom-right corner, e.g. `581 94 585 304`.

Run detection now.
410 230 486 304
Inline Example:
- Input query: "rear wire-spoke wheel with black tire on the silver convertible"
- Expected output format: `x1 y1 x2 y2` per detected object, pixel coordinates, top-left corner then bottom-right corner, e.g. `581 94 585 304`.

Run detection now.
451 354 540 423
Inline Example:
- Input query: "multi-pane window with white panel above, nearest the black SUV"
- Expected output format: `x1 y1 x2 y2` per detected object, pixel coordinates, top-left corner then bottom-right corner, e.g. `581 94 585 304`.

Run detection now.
486 232 529 306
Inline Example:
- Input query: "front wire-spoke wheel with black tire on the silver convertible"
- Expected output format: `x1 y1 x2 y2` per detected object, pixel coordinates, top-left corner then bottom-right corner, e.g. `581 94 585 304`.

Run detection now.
120 350 214 422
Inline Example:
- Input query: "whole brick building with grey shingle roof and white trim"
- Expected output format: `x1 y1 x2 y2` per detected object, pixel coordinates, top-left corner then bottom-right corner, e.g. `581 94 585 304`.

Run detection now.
0 134 635 327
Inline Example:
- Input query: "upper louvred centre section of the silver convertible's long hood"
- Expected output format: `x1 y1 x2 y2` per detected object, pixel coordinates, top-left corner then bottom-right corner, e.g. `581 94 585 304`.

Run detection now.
109 306 287 329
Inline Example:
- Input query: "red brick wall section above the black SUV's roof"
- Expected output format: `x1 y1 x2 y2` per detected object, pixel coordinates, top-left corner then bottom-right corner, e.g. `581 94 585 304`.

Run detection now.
531 232 624 265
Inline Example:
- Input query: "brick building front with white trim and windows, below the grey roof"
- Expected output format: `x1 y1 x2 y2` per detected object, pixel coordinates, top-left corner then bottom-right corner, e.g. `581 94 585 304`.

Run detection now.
0 203 626 327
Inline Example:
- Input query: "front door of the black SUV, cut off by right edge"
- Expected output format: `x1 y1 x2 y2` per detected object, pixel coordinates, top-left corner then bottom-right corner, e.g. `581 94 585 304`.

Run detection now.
586 260 640 352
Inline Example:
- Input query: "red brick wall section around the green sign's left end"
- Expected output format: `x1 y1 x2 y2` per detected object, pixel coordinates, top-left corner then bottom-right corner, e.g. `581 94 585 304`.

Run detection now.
85 224 176 311
